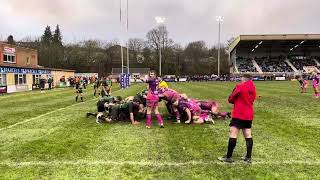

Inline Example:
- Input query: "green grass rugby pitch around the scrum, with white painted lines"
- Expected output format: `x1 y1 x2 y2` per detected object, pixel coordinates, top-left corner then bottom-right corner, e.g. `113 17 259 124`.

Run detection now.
0 82 320 179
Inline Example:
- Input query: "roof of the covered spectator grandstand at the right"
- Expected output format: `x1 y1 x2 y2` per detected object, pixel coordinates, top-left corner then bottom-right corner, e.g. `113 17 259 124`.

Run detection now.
229 34 320 53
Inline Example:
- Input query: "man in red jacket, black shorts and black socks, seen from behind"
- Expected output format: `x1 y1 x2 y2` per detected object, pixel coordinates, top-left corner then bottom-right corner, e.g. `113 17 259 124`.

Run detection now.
218 74 256 163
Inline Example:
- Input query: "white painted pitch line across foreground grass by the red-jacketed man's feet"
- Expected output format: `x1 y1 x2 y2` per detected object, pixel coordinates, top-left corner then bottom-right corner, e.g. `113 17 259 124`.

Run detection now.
0 160 320 167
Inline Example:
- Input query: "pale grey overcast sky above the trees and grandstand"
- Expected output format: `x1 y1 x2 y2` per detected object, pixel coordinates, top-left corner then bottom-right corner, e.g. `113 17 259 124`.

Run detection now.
0 0 320 45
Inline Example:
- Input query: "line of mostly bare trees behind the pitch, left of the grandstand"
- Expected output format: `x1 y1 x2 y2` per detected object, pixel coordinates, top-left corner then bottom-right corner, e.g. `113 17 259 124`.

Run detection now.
8 25 230 75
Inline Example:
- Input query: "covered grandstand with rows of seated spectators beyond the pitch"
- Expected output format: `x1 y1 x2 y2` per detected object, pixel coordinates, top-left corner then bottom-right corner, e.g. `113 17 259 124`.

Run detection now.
229 34 320 76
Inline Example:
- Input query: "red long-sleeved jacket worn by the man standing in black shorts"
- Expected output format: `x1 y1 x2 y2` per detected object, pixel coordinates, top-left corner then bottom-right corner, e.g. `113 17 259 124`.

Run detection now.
229 80 256 121
